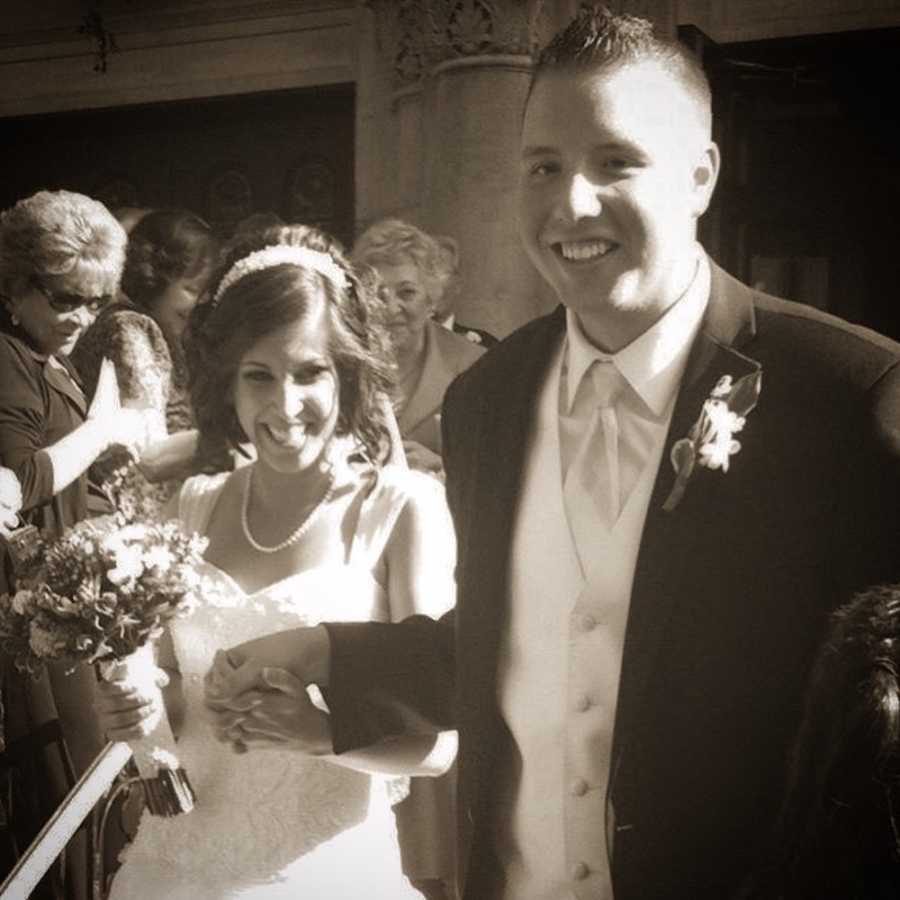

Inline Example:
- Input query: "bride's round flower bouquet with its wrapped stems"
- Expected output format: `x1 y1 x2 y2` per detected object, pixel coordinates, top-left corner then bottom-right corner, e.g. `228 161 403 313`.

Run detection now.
0 464 206 816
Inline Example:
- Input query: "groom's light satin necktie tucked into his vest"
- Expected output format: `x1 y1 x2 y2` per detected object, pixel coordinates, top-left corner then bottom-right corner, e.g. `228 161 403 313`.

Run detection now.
563 360 625 556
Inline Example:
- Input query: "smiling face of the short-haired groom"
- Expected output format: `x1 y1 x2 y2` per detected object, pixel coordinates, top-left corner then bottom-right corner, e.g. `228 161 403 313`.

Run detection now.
518 61 718 348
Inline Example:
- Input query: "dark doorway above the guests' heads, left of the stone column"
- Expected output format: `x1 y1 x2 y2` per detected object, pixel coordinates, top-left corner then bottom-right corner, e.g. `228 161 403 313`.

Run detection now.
0 85 354 248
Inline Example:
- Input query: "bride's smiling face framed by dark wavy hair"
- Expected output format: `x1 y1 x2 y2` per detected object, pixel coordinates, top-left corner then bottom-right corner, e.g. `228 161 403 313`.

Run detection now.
234 301 340 474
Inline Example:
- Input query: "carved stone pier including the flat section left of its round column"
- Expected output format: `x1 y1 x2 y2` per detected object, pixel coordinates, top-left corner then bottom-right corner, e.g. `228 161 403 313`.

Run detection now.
357 0 675 336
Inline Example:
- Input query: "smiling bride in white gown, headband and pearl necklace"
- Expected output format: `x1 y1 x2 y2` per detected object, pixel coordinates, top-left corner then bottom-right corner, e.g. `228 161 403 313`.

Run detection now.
99 226 455 900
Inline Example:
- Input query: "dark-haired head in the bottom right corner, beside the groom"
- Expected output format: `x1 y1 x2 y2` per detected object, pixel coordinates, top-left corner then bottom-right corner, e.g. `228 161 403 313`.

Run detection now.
740 585 900 900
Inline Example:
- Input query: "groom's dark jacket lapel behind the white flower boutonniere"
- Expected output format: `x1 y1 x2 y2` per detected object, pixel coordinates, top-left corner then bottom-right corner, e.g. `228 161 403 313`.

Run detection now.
613 264 760 768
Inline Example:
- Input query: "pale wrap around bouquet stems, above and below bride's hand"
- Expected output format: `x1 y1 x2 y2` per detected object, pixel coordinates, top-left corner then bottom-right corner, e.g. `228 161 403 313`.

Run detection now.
100 643 196 816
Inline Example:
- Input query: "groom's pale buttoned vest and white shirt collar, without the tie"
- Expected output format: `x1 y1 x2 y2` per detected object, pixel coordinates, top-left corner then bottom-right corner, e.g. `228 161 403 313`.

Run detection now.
495 254 709 900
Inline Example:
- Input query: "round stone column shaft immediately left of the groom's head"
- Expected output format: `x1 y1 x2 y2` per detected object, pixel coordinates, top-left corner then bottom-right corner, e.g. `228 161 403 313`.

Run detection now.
421 0 551 335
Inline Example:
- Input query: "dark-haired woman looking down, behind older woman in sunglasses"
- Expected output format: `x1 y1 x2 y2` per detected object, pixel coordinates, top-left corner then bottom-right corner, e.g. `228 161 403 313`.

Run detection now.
72 209 217 443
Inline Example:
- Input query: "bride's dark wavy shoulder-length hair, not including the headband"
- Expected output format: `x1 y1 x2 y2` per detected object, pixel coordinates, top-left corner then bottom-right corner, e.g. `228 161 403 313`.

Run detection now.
186 225 393 470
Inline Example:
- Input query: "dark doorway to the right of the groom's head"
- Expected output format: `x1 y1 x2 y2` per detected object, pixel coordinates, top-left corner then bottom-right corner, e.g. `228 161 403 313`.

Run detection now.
681 27 900 338
